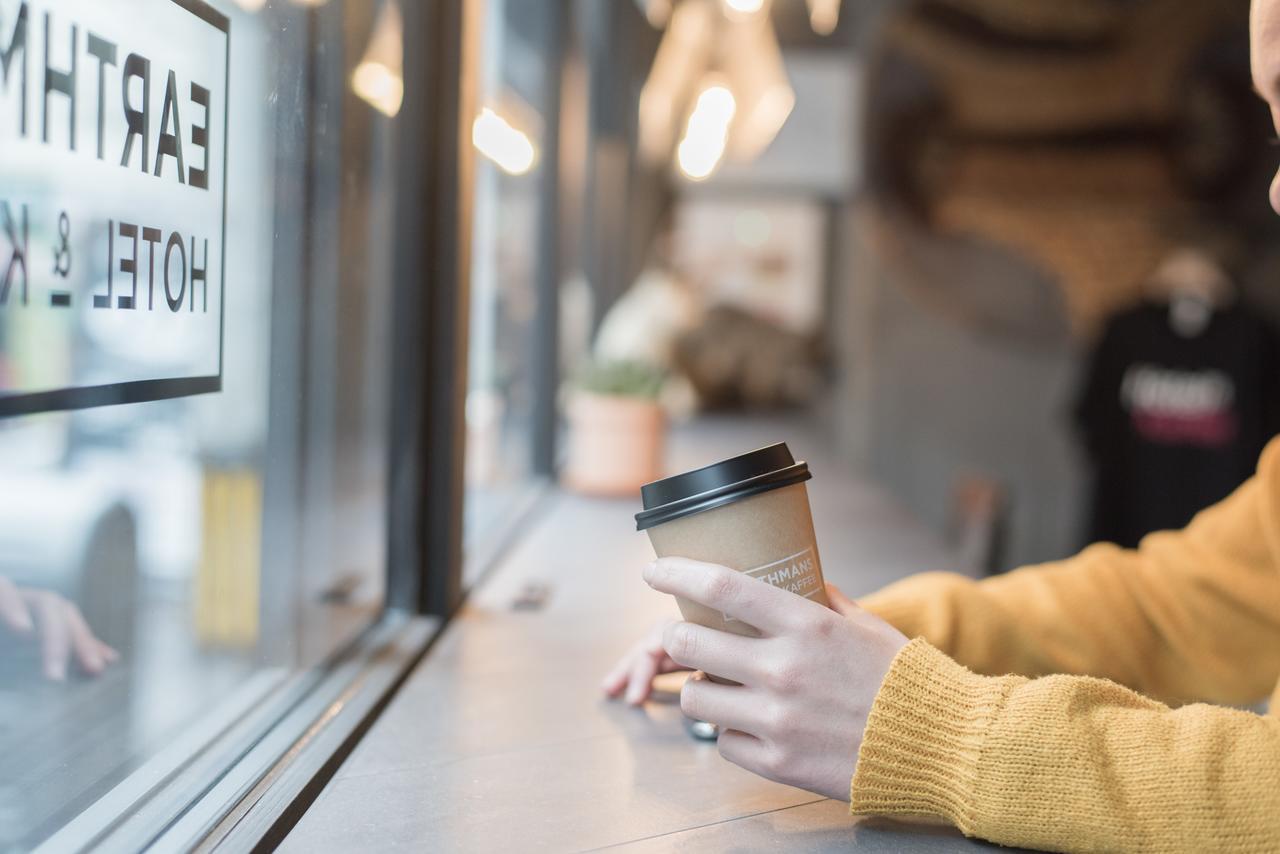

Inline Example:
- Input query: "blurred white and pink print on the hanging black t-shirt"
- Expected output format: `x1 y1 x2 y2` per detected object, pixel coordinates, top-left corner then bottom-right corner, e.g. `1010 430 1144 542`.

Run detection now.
1120 362 1238 447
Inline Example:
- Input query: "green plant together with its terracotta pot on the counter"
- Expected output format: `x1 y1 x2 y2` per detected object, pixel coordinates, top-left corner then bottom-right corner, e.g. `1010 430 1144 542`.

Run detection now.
563 360 666 495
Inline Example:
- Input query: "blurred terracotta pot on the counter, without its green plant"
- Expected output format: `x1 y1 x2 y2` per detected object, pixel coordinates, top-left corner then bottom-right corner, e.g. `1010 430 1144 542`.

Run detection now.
563 392 667 495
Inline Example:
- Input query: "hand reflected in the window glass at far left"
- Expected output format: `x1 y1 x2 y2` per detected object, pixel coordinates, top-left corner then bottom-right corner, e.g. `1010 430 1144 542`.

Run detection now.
0 577 120 681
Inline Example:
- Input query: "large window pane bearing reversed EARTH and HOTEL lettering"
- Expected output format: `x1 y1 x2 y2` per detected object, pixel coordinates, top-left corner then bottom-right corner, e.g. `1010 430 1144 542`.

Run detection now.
0 0 401 849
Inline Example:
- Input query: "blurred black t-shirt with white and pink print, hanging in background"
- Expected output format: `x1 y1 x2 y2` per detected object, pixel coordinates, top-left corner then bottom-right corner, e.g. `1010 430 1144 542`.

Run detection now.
1076 302 1280 545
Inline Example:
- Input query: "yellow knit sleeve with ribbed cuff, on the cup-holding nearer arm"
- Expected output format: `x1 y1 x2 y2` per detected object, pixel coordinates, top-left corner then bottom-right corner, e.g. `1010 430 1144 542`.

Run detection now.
850 639 1280 851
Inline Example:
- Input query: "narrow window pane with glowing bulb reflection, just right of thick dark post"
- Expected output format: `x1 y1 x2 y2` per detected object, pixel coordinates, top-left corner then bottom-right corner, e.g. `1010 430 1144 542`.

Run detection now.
463 0 547 575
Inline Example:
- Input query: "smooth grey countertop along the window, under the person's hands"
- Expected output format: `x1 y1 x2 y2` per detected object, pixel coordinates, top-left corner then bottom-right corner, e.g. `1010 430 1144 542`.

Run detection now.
283 420 1008 853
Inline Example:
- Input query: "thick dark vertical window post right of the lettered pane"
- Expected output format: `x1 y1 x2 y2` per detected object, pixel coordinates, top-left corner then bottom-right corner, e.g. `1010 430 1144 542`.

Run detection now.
388 0 480 617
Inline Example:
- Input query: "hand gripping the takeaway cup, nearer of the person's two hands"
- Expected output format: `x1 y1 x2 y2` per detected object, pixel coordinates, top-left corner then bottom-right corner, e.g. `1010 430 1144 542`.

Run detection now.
644 557 908 800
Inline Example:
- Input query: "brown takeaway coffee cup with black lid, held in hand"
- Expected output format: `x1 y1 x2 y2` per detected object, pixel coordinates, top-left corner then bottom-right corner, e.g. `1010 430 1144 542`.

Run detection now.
636 442 827 635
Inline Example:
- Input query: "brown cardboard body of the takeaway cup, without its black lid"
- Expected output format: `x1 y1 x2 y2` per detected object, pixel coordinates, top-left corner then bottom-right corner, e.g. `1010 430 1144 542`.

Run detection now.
648 483 828 637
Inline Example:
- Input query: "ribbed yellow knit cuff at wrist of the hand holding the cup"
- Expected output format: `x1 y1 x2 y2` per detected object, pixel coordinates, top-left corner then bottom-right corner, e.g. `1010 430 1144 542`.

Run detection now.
850 638 1020 832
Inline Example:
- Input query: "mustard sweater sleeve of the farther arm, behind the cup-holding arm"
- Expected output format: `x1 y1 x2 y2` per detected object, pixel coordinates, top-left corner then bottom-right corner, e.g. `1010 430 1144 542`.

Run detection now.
861 439 1280 703
